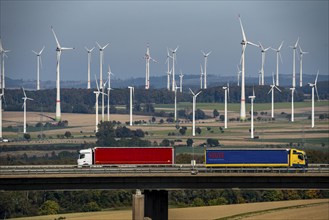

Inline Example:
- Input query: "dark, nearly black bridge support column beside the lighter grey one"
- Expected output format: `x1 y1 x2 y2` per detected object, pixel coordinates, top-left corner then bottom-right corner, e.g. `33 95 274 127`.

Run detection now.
144 190 168 220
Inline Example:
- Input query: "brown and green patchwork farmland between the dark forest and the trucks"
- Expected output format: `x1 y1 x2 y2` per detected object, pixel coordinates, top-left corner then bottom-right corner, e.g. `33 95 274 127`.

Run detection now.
0 101 329 149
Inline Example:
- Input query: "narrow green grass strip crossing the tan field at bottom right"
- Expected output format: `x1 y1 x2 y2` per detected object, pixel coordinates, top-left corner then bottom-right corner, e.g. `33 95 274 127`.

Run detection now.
216 202 328 220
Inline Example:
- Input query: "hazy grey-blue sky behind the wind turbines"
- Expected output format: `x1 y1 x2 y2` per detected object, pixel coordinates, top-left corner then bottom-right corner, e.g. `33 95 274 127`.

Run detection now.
0 0 329 81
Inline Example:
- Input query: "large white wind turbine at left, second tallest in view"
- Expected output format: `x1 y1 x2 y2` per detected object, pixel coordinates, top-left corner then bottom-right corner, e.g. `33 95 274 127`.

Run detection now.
51 26 74 121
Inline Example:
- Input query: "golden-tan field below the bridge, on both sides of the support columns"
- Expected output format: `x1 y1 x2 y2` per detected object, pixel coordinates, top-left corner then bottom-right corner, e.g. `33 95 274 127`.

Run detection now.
10 199 329 220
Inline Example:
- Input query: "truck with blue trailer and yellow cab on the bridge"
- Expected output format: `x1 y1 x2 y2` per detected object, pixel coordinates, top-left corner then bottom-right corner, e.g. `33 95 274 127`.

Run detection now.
204 148 308 168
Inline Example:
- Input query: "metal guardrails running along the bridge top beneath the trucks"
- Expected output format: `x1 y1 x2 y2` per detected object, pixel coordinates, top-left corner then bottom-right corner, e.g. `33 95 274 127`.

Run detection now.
0 165 329 175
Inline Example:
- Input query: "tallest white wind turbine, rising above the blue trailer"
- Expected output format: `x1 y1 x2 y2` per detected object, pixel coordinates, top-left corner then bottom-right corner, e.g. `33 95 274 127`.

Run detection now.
239 15 258 120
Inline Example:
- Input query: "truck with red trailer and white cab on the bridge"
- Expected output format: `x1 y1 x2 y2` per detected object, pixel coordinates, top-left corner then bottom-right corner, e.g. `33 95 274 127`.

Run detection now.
77 147 175 167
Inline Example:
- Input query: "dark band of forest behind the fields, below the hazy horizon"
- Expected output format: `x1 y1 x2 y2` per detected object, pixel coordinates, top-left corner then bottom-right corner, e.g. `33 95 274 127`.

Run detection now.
3 82 329 113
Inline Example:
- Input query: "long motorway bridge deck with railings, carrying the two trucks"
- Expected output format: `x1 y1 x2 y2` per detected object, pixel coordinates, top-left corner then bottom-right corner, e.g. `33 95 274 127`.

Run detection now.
0 165 329 191
